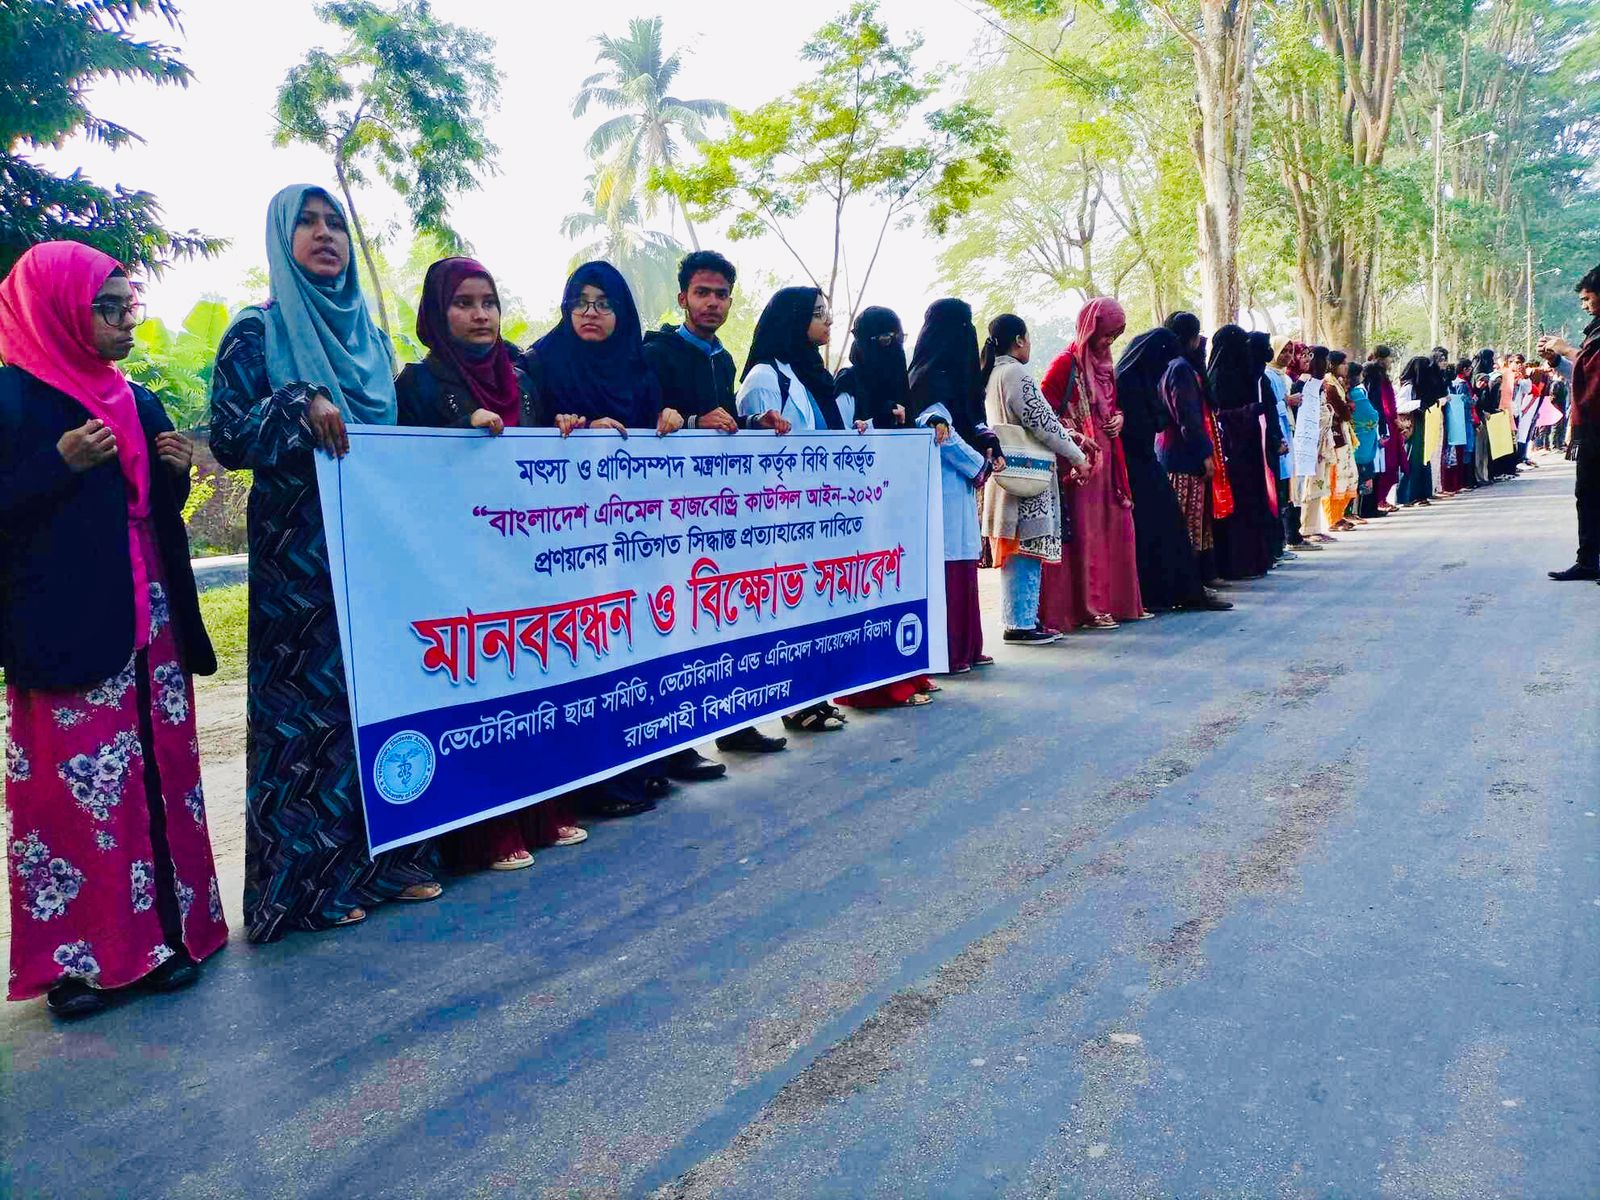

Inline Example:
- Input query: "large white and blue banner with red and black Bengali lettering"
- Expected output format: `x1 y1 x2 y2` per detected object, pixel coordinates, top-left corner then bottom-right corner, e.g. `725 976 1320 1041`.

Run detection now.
317 426 947 853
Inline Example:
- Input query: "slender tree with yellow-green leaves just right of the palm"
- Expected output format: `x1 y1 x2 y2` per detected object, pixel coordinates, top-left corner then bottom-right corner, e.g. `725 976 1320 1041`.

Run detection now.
653 0 1011 361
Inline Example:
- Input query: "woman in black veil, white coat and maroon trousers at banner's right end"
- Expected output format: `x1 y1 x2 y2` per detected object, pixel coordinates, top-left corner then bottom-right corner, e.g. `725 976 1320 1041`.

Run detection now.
907 298 1005 675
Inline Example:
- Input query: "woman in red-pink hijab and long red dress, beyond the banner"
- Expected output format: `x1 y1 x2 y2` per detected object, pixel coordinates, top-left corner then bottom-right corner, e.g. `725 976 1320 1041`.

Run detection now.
1038 296 1149 629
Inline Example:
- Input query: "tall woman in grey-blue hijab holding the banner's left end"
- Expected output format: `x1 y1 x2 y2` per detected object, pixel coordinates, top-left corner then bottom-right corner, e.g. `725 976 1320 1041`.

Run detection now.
211 184 440 942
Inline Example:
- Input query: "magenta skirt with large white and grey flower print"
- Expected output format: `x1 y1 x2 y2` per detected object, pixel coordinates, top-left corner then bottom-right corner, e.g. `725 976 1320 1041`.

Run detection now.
5 541 227 1000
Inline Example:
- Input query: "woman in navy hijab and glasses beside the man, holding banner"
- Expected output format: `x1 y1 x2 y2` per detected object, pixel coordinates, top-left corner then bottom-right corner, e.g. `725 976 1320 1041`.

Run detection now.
522 261 688 818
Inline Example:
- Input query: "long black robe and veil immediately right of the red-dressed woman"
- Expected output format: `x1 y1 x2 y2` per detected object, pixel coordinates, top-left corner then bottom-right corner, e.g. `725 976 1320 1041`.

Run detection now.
1117 328 1205 613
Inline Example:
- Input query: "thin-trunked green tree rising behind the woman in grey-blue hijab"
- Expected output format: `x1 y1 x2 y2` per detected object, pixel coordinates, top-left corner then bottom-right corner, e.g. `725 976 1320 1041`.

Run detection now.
275 0 499 333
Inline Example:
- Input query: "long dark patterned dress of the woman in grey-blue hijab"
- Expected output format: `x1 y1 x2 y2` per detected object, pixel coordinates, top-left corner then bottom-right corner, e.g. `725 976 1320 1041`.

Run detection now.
211 317 437 942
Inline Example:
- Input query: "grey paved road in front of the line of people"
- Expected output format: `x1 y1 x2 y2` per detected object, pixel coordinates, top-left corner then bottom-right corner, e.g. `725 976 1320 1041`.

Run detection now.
0 467 1600 1200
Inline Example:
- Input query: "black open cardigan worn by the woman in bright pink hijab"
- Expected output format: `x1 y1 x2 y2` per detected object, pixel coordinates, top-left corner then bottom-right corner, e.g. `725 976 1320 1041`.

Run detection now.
0 366 216 690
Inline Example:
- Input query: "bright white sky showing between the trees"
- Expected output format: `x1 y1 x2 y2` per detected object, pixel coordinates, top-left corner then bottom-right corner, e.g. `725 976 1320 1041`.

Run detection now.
34 0 984 328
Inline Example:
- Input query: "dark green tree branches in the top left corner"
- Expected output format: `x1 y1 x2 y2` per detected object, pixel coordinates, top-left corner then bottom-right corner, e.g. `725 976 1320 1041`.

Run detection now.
0 0 226 275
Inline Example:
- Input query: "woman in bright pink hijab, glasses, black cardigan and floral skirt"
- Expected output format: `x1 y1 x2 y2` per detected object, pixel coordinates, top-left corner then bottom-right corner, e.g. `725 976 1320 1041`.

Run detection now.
0 242 227 1016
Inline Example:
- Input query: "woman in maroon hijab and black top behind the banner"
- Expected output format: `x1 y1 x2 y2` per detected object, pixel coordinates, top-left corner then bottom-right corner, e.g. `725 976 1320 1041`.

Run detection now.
395 258 589 870
